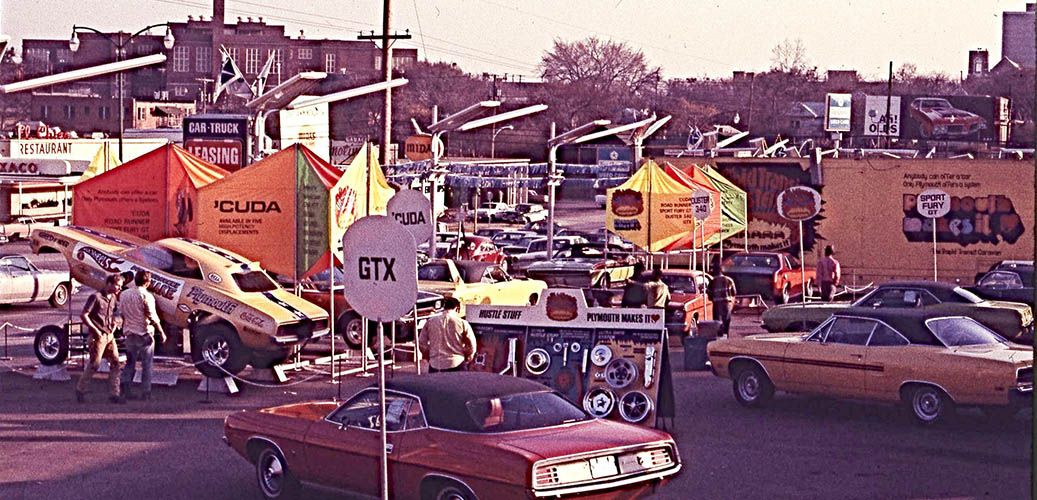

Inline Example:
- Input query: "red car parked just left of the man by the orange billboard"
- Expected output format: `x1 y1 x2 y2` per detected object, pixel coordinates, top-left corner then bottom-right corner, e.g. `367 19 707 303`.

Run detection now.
721 252 817 304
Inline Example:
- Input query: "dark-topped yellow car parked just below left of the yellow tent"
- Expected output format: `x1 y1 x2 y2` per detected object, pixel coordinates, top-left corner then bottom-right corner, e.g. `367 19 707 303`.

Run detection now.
526 243 637 288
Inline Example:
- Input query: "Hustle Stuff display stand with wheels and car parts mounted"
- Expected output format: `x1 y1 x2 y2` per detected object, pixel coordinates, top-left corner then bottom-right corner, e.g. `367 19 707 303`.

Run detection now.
467 288 675 425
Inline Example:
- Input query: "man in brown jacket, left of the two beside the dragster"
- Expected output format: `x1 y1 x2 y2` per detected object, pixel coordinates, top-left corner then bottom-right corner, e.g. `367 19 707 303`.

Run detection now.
76 274 127 405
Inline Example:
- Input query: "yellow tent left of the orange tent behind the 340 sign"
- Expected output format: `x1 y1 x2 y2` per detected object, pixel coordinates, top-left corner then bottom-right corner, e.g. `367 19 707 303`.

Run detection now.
606 160 697 252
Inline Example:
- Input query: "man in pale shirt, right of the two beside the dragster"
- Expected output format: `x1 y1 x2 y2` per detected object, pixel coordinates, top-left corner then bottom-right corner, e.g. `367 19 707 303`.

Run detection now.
119 270 166 400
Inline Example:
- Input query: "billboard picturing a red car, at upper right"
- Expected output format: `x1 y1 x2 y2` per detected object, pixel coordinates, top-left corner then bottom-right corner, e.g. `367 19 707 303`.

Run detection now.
900 95 999 141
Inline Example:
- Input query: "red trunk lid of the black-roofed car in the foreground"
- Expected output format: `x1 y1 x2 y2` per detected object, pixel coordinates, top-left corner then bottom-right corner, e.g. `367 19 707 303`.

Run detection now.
501 418 671 459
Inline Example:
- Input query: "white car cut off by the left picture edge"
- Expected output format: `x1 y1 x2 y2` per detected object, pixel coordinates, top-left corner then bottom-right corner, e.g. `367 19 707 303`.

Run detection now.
0 255 75 307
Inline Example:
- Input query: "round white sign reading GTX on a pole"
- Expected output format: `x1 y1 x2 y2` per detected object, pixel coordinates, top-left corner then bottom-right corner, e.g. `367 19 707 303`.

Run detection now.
342 216 418 322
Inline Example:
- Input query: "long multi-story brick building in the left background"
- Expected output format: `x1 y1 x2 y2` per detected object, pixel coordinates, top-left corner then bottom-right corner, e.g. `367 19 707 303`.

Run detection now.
21 17 418 136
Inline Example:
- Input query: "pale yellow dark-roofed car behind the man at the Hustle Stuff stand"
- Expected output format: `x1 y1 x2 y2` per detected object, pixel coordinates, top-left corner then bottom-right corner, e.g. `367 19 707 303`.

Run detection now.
418 258 548 306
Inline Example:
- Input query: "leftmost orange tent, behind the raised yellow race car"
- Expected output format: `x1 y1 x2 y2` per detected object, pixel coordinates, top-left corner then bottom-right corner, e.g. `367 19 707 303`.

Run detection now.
72 144 228 241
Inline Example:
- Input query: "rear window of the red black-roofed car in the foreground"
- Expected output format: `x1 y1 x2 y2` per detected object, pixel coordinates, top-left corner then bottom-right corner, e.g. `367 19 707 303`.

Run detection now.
465 392 591 433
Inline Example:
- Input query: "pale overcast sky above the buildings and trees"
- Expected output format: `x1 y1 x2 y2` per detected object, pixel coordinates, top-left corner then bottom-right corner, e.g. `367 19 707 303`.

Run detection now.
0 0 1026 78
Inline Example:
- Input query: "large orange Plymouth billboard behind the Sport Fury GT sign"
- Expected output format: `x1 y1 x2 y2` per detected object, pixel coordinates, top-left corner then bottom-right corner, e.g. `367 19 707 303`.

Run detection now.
817 159 1034 285
